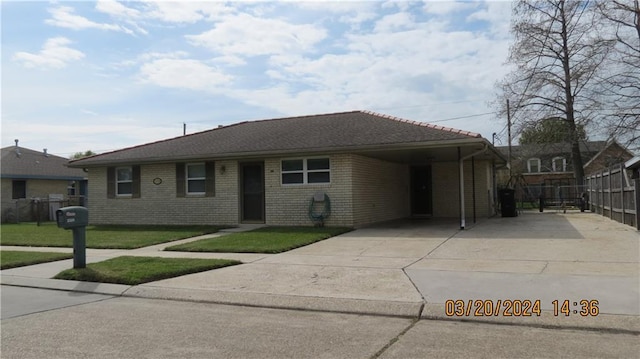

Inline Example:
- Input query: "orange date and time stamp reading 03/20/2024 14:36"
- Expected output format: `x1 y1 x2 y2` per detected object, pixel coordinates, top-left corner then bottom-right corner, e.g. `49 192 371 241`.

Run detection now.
444 299 600 317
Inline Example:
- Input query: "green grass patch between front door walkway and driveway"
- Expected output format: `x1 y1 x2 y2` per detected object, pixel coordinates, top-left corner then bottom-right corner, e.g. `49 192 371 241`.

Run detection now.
165 227 351 253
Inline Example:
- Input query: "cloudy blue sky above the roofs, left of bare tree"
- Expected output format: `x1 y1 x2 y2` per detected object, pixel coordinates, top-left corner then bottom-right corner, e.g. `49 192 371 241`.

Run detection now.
0 0 511 157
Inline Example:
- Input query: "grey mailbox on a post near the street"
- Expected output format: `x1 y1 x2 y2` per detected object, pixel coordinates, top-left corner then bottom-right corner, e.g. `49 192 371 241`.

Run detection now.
56 206 89 268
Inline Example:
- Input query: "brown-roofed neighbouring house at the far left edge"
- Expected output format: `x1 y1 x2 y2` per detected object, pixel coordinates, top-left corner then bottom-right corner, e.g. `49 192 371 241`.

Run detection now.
0 140 87 222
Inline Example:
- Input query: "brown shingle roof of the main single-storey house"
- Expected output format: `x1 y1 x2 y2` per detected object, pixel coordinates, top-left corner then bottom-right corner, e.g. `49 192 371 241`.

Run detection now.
72 111 481 166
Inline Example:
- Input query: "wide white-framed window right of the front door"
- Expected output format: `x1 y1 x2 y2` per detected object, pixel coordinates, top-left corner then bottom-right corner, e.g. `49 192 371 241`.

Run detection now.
281 157 331 185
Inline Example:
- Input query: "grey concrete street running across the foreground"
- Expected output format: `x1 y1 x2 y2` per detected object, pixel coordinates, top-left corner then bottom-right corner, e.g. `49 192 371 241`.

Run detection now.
2 286 640 359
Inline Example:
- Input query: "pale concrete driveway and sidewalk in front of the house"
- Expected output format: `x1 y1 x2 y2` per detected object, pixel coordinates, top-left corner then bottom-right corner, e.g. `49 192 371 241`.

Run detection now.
1 212 640 332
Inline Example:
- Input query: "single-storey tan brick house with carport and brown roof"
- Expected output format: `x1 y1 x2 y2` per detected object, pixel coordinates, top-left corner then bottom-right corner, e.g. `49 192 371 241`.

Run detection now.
70 111 505 227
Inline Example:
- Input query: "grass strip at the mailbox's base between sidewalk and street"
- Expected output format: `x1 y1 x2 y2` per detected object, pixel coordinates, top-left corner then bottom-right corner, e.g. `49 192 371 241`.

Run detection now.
54 256 242 285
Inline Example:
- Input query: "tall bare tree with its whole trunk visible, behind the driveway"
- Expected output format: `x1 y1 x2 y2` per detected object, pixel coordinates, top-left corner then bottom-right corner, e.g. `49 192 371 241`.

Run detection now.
499 0 613 184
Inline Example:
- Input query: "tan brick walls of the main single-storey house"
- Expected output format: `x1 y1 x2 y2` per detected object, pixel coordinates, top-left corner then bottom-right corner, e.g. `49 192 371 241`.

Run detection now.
88 154 492 226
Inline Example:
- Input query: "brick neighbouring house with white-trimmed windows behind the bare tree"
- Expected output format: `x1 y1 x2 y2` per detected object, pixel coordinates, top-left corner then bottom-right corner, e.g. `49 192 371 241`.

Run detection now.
497 141 633 205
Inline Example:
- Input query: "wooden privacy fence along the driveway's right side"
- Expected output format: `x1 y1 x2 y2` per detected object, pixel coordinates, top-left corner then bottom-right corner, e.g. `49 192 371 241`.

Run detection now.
585 164 640 230
